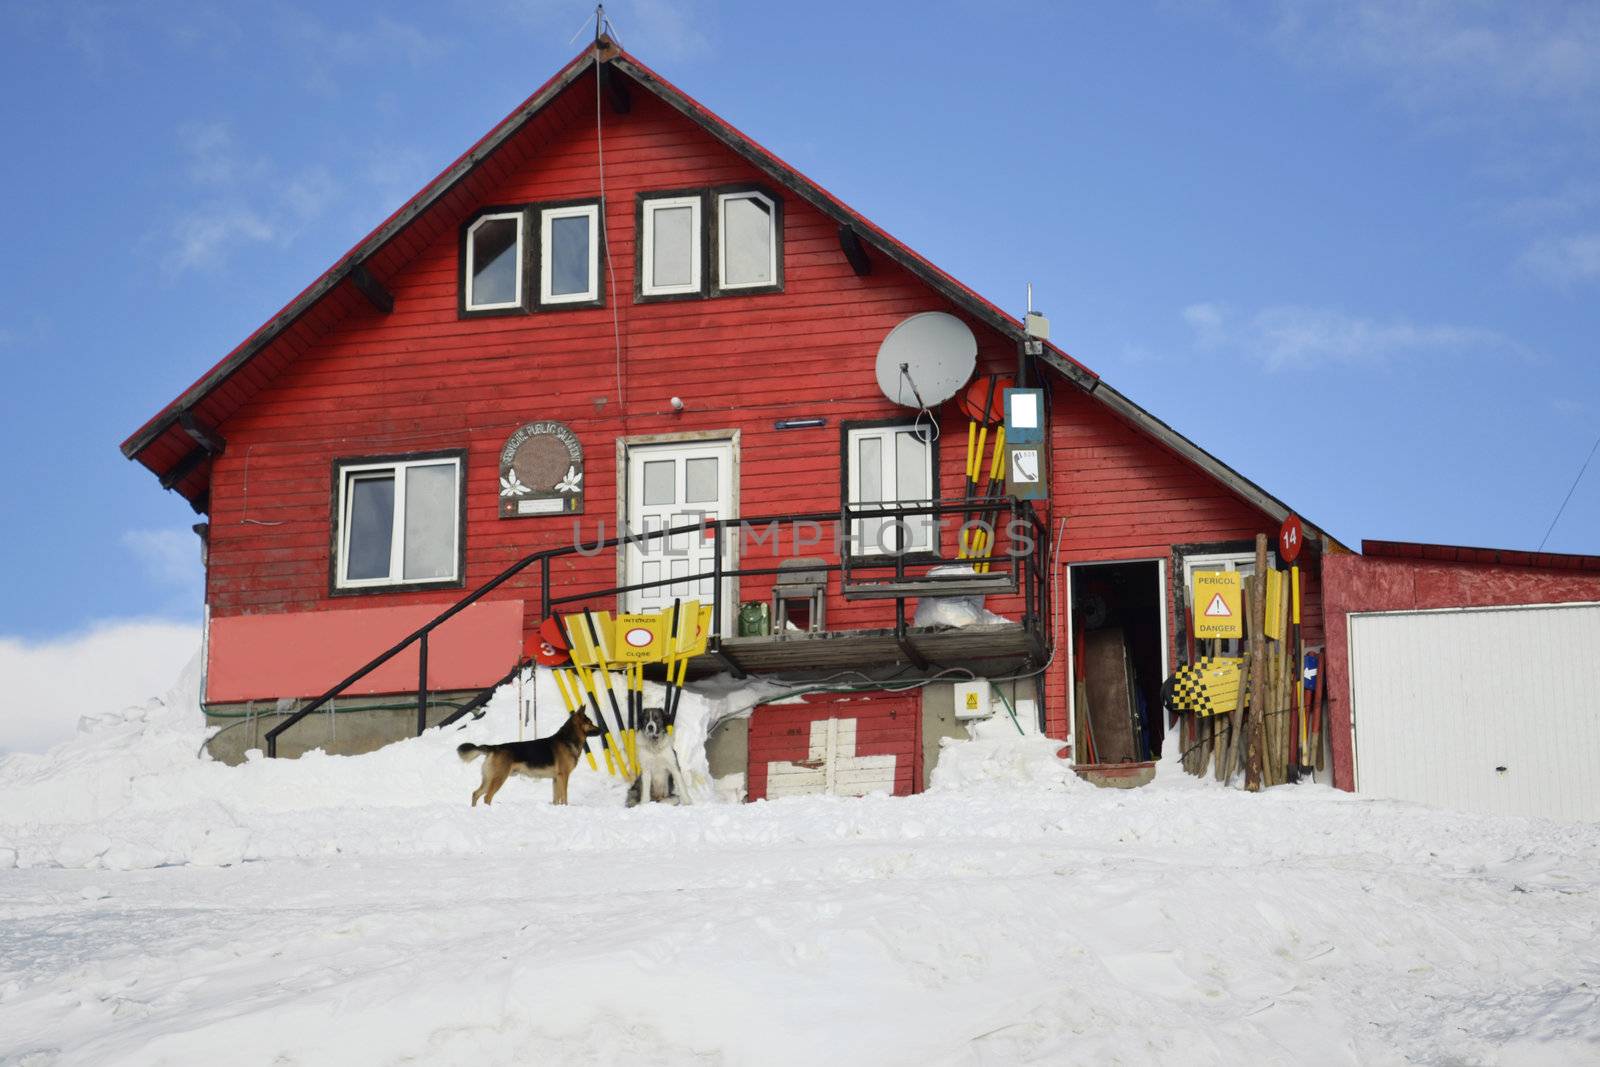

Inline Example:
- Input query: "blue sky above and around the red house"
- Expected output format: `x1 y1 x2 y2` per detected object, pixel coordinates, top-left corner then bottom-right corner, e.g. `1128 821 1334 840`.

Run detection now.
0 0 1600 640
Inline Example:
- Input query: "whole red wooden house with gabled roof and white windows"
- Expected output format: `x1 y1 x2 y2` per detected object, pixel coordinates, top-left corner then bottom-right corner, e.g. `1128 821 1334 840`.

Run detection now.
123 38 1331 792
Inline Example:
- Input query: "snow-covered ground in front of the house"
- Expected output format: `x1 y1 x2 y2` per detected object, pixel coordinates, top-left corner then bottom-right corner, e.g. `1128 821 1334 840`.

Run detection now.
0 662 1600 1067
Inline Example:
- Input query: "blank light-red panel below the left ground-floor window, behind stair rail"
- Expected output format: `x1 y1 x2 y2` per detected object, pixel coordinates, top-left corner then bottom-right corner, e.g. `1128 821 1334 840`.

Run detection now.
205 593 522 704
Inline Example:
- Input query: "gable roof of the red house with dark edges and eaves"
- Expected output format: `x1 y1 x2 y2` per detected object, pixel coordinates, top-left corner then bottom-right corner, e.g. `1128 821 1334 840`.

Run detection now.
122 37 1344 550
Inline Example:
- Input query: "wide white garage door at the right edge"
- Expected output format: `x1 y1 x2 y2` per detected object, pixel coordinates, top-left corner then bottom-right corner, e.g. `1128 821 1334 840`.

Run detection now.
1350 605 1600 819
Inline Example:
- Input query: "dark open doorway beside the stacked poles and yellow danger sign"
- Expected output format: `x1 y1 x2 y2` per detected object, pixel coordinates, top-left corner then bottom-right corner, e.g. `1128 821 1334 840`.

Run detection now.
1072 560 1163 763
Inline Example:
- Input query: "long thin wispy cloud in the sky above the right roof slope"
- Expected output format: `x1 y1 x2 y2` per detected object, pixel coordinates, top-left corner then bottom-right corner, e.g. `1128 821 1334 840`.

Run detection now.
1182 304 1526 371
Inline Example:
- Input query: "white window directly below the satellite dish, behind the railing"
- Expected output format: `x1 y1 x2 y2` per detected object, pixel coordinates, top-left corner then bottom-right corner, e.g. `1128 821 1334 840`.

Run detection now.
845 426 934 555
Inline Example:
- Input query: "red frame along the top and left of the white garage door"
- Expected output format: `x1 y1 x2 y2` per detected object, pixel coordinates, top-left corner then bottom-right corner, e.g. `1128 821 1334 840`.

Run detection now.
1323 556 1600 789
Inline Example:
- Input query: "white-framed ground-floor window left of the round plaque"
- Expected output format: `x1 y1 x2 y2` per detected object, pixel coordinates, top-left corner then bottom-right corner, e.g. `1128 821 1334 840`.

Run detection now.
338 456 461 589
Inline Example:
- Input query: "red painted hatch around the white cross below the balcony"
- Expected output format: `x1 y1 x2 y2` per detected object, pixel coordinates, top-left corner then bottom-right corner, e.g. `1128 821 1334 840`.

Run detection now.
746 693 922 800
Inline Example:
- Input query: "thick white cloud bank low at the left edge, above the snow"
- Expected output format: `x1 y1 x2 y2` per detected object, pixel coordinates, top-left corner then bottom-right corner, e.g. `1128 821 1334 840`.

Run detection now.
0 619 200 752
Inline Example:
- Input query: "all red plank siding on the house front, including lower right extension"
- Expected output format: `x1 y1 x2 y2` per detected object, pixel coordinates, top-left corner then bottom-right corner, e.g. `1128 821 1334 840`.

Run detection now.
193 60 1317 736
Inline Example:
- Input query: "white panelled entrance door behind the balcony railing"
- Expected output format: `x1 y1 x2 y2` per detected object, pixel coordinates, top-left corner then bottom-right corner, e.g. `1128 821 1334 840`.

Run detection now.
624 440 739 637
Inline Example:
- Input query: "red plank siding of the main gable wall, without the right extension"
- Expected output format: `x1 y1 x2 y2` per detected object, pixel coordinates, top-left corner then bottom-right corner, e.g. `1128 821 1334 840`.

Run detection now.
208 85 1019 627
